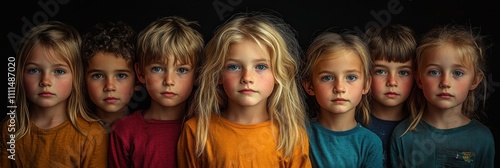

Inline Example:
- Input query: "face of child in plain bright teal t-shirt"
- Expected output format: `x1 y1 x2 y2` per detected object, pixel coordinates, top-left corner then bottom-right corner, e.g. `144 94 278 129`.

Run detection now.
305 50 370 115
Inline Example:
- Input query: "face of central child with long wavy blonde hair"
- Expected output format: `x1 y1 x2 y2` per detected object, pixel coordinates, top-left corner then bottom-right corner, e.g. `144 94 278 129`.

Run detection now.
221 40 275 108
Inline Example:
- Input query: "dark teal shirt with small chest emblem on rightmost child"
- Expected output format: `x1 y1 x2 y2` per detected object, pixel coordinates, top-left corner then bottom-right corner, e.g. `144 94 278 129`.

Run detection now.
390 119 495 168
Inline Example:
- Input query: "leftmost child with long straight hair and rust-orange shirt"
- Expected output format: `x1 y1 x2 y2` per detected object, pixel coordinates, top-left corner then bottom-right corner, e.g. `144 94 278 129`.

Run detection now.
0 21 108 167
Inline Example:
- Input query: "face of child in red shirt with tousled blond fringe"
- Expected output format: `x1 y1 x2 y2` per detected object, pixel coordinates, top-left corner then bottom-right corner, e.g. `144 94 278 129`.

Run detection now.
136 56 195 107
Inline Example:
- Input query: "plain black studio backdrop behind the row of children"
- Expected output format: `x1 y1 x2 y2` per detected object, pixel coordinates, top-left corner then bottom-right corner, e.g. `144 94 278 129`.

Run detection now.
0 0 500 164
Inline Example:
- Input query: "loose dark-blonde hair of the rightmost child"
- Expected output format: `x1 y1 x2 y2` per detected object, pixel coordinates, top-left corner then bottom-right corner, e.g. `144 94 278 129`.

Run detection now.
403 25 486 135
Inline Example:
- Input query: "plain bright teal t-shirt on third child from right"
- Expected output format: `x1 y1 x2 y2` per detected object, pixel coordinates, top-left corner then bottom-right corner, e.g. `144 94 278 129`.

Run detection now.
307 120 383 168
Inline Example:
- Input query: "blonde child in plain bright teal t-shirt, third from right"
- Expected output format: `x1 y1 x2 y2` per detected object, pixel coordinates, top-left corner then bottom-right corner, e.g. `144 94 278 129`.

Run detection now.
303 31 383 167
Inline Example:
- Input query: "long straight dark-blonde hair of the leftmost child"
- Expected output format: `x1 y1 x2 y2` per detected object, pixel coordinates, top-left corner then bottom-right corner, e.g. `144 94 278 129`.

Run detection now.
15 21 96 139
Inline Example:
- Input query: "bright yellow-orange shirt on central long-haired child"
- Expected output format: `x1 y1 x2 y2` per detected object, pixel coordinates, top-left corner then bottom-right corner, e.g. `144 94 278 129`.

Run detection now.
177 116 311 168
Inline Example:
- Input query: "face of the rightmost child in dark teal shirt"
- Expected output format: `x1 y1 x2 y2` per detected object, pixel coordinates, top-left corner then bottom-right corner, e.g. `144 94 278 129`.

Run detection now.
417 45 480 110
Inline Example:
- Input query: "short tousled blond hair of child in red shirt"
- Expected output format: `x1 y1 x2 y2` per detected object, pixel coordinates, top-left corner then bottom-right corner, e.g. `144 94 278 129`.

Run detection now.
136 16 204 75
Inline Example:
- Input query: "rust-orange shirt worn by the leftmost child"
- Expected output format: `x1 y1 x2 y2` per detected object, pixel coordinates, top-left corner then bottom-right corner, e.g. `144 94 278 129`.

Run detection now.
0 117 109 168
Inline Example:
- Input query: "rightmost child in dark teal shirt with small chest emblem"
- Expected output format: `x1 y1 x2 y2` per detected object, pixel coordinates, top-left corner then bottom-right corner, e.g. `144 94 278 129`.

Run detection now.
390 25 495 167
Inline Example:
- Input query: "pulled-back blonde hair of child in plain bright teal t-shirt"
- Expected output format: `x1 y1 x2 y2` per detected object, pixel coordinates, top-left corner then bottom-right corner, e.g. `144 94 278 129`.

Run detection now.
302 31 372 125
